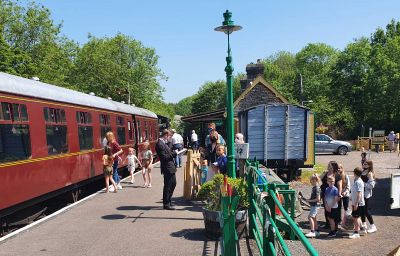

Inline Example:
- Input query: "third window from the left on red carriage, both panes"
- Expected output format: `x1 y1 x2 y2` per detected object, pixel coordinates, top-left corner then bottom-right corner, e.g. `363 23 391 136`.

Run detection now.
76 111 93 150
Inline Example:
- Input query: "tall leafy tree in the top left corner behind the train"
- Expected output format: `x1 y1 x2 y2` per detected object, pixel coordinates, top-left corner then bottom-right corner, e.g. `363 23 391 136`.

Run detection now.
0 0 74 82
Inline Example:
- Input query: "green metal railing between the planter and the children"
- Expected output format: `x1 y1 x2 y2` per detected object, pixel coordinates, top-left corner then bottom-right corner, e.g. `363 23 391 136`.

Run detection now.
246 161 318 256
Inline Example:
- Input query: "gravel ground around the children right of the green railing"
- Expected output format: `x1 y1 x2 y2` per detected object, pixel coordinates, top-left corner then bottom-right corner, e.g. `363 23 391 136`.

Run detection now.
288 151 400 255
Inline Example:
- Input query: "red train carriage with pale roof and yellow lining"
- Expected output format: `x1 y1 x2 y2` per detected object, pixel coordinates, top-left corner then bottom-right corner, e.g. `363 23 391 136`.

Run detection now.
0 72 158 217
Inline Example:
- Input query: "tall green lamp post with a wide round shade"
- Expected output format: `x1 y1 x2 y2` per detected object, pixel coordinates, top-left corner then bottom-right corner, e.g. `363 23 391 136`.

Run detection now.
214 10 242 178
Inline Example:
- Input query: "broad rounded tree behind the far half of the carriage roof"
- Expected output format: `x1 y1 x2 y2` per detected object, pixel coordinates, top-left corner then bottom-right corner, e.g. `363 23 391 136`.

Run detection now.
69 34 166 111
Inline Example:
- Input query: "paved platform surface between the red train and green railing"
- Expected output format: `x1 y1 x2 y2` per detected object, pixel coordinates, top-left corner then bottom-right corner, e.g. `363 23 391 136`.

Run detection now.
0 157 223 256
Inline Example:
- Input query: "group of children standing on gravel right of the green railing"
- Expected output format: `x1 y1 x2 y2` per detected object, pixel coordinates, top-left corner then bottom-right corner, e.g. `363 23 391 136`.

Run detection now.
306 152 377 238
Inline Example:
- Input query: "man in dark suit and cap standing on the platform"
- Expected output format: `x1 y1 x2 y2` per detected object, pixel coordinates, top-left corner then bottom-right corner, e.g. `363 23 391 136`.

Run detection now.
156 129 177 210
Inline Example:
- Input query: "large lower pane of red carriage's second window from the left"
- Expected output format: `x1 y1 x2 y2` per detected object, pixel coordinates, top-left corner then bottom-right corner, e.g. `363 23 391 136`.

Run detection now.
46 125 68 155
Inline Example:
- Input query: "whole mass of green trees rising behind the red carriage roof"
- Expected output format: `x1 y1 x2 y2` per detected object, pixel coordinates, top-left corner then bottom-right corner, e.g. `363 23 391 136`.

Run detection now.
0 0 169 117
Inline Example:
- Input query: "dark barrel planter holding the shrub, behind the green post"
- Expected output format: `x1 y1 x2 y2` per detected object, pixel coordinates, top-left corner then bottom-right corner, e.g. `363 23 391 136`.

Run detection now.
203 208 247 239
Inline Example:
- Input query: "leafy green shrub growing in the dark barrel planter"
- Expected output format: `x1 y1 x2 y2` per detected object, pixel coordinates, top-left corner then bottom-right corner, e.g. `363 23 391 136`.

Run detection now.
197 174 249 211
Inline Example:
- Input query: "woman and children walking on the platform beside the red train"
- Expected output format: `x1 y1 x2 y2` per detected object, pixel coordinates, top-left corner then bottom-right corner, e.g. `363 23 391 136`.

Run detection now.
102 132 153 193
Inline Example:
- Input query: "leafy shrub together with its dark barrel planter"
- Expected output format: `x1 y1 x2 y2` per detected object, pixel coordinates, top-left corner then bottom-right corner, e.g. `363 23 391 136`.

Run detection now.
197 174 249 239
